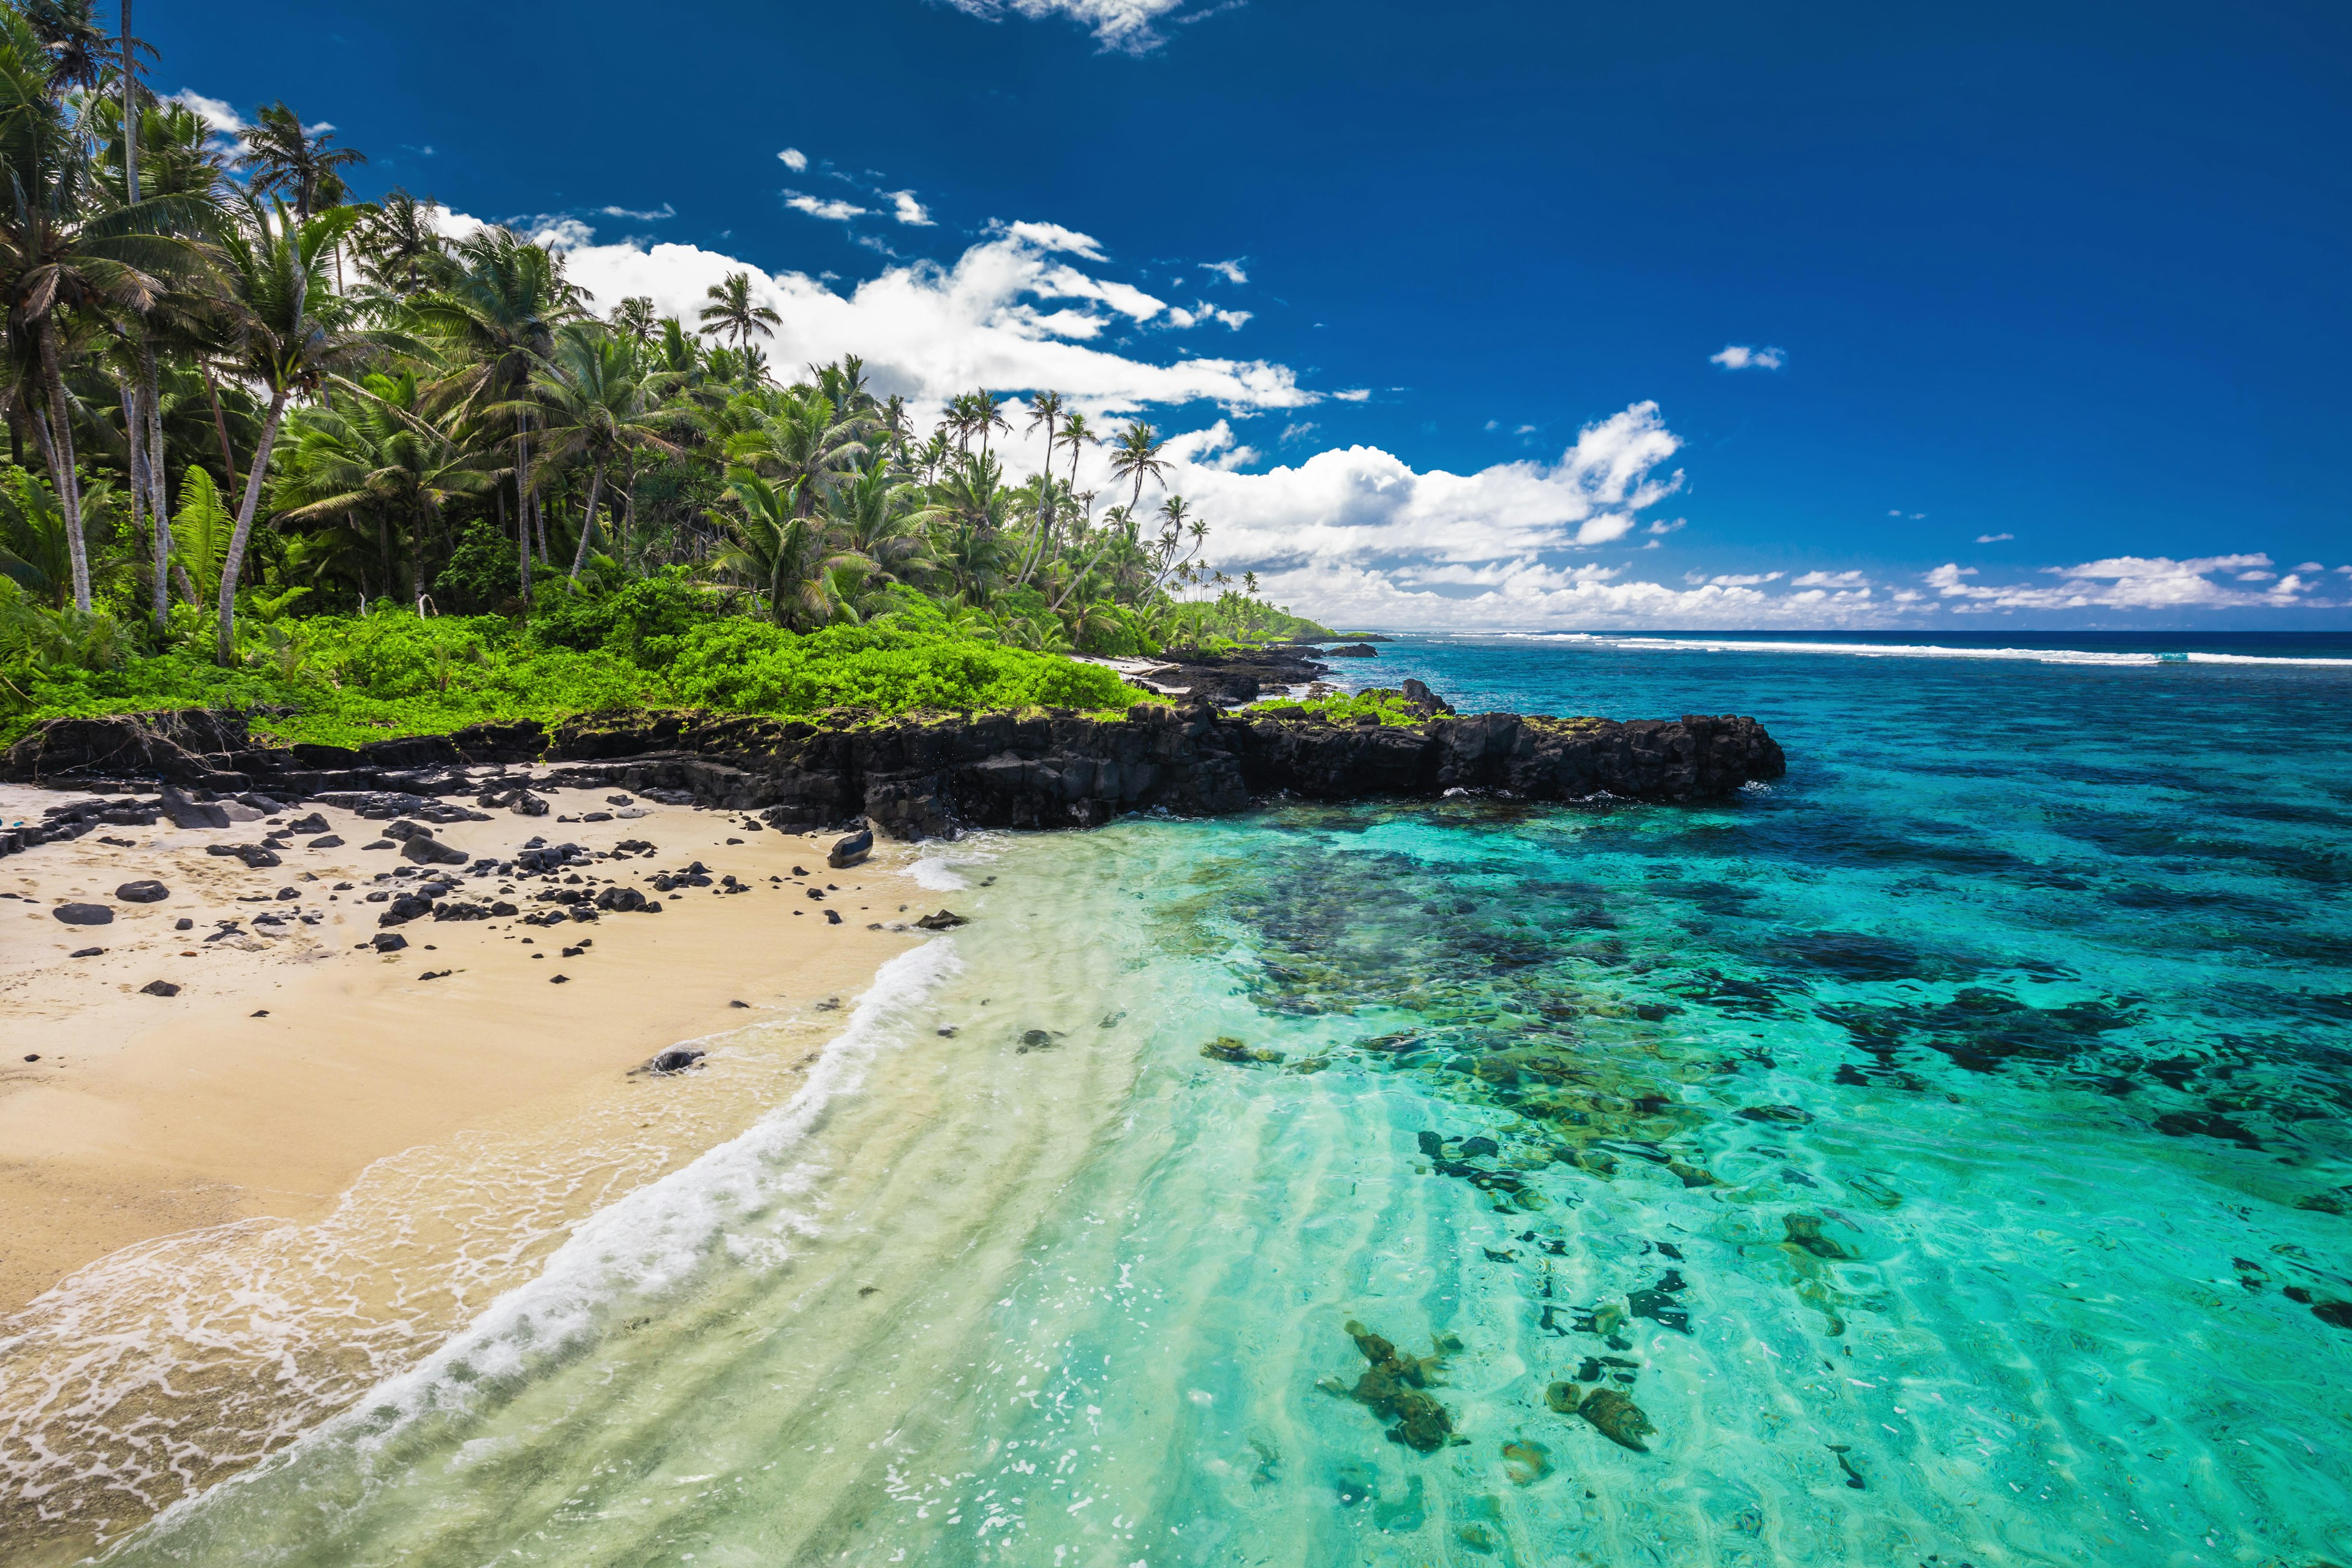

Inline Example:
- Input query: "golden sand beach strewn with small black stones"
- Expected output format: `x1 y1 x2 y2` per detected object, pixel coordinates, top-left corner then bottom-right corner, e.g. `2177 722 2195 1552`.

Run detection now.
0 783 936 1314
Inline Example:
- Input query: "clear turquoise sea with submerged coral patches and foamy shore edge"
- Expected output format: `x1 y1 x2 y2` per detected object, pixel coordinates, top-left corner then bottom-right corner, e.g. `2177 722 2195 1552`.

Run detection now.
55 639 2352 1568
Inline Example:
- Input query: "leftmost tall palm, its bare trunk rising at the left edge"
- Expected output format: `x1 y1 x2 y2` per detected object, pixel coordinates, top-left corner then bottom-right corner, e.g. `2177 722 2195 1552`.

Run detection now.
0 7 205 611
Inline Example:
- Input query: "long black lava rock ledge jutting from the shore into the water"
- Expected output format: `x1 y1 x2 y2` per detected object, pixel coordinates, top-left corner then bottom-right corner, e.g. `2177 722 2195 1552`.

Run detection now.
0 687 1785 842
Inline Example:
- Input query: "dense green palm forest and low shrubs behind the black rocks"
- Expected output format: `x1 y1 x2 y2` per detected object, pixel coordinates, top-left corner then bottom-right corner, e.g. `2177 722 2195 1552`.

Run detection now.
0 0 1322 743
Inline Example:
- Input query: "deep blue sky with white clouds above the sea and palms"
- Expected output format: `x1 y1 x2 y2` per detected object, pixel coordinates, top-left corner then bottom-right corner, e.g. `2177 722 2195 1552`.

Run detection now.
156 0 2352 632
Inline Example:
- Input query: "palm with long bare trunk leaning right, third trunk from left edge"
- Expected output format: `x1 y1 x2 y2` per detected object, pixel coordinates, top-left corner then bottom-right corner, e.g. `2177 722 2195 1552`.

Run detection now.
216 205 367 665
